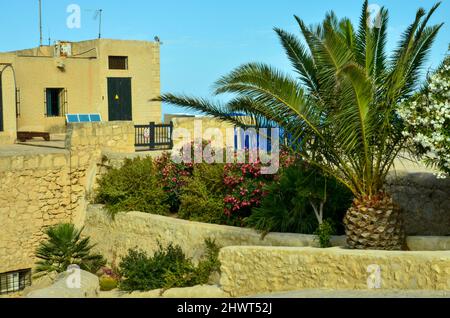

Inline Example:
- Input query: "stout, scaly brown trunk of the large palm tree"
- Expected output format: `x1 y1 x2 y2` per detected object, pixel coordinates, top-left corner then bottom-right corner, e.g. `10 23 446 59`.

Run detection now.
344 193 407 250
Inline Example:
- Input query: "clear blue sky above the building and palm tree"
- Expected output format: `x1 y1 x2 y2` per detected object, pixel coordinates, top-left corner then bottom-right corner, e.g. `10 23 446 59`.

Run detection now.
0 0 450 117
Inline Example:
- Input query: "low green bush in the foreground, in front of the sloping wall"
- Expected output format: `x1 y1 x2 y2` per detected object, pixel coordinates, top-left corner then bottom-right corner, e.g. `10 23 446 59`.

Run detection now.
119 241 219 291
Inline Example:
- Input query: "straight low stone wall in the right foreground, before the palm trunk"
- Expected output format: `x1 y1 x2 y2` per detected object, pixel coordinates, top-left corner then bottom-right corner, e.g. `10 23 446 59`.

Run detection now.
219 246 450 297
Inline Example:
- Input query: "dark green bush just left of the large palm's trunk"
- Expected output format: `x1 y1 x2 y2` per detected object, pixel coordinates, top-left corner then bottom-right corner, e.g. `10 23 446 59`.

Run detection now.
246 163 352 234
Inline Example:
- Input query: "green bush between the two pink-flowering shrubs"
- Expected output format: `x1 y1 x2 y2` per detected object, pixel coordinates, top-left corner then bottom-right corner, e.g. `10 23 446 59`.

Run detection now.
178 164 227 224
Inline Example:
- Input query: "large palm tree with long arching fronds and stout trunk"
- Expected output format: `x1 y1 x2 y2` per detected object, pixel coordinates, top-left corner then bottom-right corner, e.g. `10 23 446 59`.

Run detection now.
159 1 442 249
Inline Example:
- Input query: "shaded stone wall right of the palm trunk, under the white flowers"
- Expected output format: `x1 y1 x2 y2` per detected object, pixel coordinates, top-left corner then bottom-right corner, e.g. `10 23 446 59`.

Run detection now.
386 171 450 236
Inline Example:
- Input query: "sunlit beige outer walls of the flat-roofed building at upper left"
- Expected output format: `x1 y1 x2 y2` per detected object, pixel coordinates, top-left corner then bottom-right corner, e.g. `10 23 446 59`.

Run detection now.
0 39 162 133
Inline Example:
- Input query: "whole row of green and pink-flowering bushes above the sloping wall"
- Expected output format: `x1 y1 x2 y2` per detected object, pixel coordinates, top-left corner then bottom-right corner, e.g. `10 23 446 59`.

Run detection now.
96 142 351 234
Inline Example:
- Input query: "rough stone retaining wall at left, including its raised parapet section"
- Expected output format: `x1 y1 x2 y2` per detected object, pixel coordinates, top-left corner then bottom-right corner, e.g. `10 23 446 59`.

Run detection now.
0 122 134 273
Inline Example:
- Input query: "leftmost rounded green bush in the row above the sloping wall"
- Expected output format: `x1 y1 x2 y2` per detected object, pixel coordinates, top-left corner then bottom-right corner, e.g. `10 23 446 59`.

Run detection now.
95 158 169 216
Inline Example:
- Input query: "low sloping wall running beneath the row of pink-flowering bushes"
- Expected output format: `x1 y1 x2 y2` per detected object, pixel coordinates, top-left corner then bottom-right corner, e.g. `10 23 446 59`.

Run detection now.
84 205 450 262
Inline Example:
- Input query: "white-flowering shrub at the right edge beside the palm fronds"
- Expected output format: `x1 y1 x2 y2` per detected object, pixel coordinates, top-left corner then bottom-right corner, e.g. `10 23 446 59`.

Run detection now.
398 52 450 178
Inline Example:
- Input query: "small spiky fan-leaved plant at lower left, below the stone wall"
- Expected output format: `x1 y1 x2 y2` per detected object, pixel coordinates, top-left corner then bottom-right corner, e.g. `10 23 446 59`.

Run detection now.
35 224 106 276
